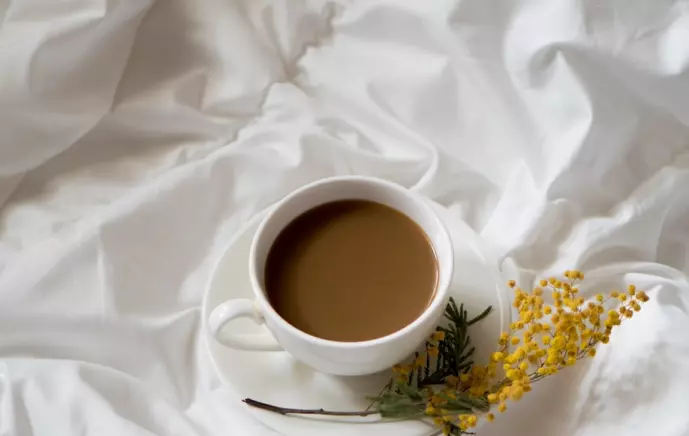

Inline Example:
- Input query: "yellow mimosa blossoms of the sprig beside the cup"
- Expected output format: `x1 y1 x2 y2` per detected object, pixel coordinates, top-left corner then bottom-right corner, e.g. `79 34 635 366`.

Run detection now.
418 271 648 434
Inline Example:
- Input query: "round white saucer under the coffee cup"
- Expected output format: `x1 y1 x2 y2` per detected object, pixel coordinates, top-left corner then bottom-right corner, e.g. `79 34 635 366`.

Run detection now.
202 207 510 436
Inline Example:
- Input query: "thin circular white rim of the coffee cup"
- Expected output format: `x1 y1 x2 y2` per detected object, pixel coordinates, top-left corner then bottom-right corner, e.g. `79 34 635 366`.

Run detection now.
249 176 454 349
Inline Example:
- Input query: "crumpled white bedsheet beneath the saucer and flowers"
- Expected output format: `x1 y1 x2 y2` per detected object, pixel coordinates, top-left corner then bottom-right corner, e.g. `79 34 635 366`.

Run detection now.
0 0 689 436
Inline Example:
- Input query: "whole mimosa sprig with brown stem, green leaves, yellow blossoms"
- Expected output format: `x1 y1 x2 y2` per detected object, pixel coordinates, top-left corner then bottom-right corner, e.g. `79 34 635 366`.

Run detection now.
244 271 649 435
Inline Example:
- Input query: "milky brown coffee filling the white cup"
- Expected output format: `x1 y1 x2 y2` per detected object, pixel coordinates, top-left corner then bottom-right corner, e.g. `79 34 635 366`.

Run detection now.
265 200 438 342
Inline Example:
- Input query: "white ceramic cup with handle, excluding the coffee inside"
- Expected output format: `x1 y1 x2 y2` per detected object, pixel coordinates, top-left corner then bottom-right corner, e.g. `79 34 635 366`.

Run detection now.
208 176 454 375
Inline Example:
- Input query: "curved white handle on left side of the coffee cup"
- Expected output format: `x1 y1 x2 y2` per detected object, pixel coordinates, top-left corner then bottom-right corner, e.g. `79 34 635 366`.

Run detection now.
208 298 282 351
